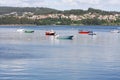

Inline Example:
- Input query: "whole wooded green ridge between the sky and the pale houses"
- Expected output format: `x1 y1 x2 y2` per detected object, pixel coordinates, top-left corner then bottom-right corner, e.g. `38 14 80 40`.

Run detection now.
0 7 120 15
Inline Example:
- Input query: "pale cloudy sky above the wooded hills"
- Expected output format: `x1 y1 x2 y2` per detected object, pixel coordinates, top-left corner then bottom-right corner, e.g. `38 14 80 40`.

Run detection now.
0 0 120 11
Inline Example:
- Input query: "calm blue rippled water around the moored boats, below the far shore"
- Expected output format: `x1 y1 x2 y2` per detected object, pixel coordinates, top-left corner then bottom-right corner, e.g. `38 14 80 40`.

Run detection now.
0 26 120 80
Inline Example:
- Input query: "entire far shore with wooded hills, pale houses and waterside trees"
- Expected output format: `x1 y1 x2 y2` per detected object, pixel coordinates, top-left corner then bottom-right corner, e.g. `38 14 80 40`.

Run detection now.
0 7 120 25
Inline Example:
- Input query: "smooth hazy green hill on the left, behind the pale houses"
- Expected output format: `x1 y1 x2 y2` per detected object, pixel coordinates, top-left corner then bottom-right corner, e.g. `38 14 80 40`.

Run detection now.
0 7 59 15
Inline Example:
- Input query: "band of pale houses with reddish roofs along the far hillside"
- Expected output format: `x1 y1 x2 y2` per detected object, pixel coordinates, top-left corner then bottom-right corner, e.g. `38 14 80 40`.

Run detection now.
15 12 120 21
